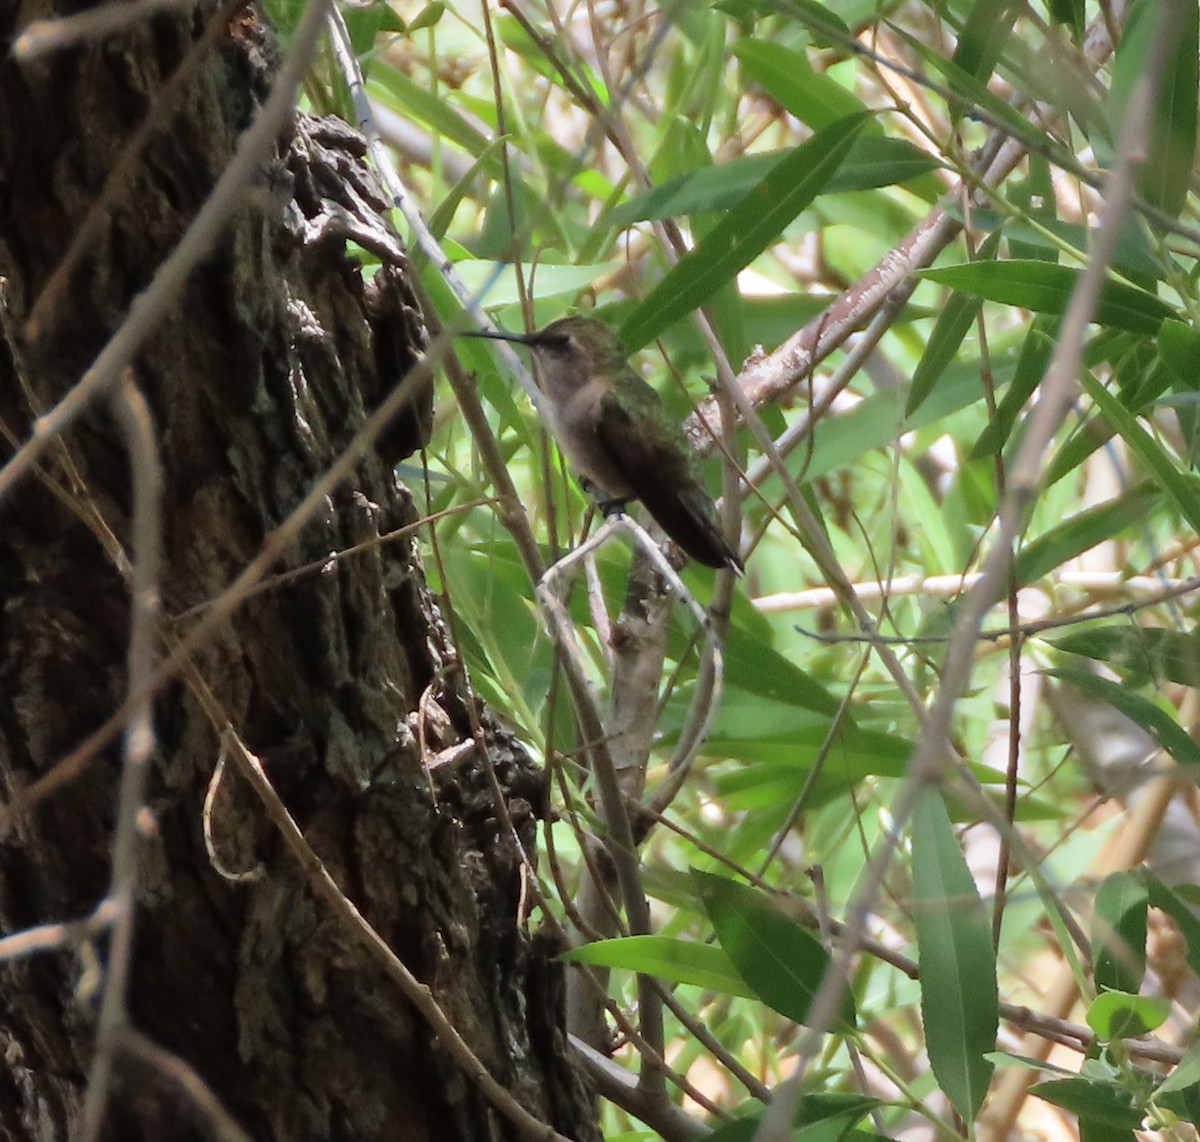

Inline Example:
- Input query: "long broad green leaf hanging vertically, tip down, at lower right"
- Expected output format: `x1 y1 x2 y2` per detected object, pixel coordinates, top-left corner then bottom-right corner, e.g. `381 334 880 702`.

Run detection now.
912 789 1000 1122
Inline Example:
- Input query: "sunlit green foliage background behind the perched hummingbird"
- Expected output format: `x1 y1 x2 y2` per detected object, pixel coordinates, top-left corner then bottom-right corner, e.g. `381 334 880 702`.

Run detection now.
314 0 1200 1137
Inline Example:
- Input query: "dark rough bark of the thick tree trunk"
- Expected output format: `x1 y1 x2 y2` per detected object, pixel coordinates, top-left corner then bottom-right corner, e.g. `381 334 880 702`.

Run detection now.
0 0 595 1140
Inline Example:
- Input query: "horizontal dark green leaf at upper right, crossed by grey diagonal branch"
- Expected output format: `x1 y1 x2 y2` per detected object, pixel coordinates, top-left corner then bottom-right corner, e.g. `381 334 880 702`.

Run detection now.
920 259 1174 333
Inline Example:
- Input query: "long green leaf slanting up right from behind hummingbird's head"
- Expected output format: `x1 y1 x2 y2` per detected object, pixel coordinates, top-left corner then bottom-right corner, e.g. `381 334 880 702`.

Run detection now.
620 118 864 353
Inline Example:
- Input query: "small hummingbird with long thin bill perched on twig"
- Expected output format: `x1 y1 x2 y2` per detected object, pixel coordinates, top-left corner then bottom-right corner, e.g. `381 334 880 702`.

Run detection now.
467 317 744 575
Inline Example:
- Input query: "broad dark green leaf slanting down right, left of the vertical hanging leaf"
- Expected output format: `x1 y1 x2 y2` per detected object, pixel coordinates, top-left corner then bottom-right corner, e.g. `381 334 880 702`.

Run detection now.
691 868 854 1029
